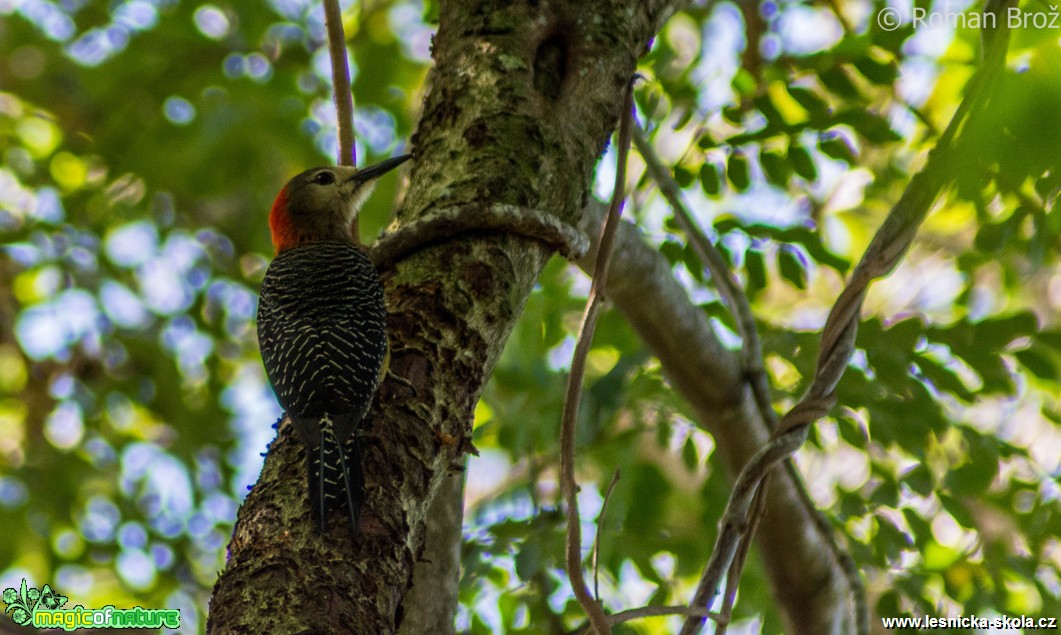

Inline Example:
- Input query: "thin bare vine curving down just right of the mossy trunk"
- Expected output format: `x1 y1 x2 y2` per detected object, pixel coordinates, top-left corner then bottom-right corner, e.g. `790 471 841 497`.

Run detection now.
560 80 633 635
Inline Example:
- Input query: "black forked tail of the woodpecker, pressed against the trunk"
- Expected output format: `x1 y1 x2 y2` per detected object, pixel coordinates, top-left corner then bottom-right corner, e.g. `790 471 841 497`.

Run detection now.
307 425 365 534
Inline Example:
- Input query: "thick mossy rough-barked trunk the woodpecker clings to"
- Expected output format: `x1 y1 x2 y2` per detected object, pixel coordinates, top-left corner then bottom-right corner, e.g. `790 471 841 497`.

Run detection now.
208 0 682 634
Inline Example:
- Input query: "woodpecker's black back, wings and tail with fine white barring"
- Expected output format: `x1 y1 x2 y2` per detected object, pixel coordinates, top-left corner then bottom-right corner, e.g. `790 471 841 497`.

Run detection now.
258 241 387 532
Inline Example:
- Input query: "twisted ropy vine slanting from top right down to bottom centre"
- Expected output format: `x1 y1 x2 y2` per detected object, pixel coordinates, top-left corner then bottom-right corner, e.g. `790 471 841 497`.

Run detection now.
681 7 1013 635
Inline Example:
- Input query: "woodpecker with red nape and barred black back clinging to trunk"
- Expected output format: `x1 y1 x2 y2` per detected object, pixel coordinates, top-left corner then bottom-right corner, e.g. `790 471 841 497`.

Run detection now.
258 155 410 534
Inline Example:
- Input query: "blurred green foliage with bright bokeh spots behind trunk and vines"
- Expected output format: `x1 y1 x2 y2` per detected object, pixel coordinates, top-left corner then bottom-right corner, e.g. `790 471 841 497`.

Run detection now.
0 0 1061 633
